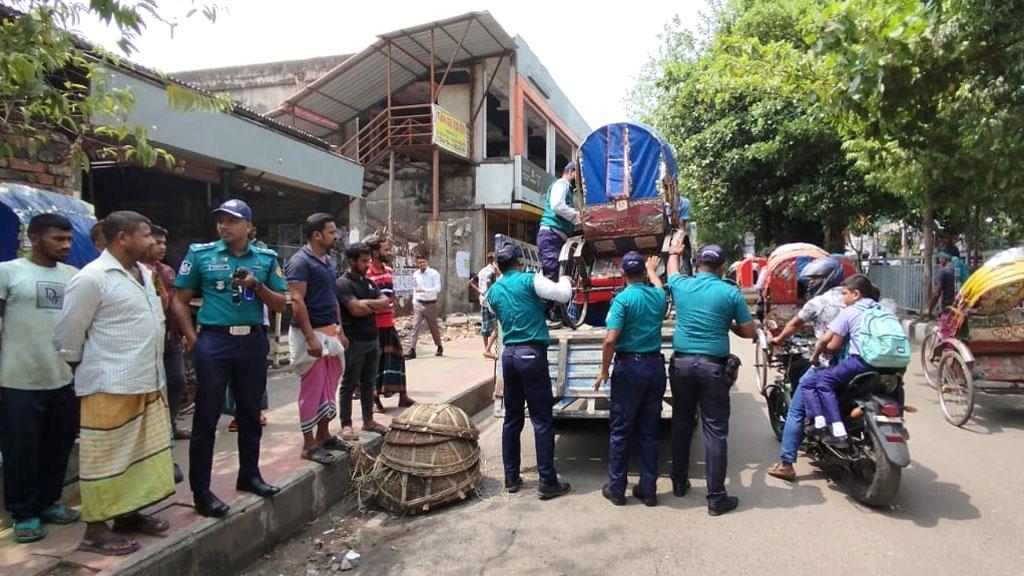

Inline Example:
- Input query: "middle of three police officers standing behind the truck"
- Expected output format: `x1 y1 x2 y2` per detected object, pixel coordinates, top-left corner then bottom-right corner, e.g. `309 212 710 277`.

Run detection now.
594 252 665 506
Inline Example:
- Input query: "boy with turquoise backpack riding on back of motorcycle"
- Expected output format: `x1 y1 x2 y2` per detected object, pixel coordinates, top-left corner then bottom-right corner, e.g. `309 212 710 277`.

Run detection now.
800 274 910 447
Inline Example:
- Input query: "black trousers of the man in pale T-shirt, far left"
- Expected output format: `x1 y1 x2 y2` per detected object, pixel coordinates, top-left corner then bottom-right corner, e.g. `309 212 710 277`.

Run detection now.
0 384 79 522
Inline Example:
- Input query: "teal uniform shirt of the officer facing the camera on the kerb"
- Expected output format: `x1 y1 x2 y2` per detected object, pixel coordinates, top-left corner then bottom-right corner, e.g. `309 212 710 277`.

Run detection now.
174 240 288 326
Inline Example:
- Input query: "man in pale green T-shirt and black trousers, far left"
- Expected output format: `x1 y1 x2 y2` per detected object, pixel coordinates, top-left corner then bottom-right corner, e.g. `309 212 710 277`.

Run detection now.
0 214 79 542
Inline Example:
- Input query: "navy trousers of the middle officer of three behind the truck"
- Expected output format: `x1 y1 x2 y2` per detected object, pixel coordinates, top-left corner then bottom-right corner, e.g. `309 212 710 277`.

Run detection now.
608 356 666 494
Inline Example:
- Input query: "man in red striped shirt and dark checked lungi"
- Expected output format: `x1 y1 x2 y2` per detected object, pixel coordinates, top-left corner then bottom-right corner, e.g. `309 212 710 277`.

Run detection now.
365 236 416 412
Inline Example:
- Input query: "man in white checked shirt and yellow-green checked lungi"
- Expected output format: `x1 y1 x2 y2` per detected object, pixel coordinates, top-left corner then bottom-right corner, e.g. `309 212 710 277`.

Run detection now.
54 211 174 556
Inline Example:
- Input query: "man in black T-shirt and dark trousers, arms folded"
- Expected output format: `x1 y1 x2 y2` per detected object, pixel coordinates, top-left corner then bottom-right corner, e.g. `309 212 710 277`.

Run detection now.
335 243 390 441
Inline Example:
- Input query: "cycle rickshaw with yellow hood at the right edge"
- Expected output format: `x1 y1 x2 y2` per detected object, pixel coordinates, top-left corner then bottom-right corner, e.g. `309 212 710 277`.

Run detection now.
922 247 1024 426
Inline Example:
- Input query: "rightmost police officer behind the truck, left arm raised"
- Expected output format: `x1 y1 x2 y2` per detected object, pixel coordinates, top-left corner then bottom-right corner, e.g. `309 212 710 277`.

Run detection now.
667 235 756 516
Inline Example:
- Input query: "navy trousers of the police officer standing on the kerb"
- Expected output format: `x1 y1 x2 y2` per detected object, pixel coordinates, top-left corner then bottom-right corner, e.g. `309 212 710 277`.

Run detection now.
188 330 269 494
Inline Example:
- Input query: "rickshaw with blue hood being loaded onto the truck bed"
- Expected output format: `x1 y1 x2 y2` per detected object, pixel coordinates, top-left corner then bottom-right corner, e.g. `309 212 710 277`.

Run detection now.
559 122 689 329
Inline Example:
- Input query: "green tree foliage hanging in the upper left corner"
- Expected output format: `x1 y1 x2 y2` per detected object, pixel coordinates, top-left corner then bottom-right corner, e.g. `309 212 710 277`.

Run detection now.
0 0 231 169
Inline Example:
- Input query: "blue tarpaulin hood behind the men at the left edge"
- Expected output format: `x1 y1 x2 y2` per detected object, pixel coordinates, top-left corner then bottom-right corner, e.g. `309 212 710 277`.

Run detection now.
0 182 98 268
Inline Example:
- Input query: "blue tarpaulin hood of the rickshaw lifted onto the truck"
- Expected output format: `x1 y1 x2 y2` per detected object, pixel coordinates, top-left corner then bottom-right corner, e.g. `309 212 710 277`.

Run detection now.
580 122 689 206
